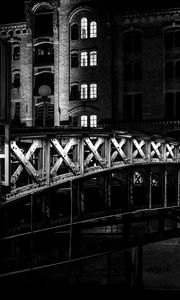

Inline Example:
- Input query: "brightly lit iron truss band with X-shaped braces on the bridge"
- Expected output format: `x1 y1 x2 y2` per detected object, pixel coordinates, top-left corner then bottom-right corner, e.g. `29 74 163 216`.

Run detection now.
1 128 180 201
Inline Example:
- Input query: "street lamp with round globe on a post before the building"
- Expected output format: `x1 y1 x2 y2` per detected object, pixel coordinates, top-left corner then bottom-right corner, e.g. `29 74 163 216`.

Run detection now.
38 84 51 127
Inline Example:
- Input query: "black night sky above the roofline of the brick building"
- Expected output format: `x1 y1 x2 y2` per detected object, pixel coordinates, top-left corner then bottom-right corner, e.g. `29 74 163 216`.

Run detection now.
0 0 180 24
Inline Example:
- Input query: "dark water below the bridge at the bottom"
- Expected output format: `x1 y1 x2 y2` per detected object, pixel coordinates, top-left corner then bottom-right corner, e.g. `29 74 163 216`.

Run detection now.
1 239 180 299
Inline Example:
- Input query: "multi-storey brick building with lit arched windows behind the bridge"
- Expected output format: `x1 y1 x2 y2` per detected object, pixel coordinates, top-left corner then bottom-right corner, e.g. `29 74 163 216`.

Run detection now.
0 0 180 131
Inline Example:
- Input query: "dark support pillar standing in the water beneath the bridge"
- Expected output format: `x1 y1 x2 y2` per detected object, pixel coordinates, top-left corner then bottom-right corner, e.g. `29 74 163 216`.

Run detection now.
125 245 144 290
